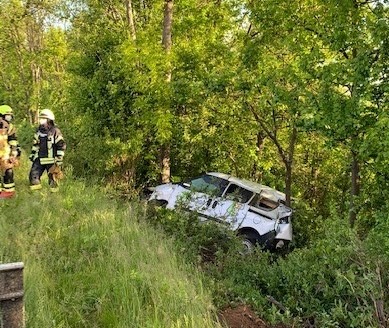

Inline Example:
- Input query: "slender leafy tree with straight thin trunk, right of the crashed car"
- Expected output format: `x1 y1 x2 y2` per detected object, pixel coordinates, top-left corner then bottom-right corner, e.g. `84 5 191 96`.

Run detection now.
305 1 381 226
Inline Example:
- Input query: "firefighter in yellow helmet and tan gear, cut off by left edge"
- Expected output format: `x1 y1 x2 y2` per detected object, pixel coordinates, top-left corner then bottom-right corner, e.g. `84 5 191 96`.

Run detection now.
0 105 21 198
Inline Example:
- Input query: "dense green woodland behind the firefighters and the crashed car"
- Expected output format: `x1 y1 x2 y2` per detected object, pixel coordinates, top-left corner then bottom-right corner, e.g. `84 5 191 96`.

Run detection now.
0 0 389 244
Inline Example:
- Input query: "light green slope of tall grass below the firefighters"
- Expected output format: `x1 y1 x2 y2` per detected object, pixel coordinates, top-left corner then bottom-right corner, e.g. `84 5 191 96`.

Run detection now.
0 160 221 328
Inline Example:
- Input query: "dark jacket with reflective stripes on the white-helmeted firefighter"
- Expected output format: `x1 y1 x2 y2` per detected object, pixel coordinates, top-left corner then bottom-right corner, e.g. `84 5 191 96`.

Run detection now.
30 125 66 165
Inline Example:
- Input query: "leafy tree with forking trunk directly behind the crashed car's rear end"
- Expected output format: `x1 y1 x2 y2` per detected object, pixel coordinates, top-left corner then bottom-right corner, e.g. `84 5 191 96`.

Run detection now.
235 1 312 205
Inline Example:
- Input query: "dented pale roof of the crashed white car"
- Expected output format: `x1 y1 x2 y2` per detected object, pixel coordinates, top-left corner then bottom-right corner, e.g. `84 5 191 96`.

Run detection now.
207 172 286 202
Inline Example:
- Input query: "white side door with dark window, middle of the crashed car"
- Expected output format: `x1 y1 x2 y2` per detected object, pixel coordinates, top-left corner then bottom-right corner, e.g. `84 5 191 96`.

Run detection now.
205 183 253 229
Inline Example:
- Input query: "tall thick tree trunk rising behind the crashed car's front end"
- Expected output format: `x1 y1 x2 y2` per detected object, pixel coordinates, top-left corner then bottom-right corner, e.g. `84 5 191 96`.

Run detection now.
160 0 173 183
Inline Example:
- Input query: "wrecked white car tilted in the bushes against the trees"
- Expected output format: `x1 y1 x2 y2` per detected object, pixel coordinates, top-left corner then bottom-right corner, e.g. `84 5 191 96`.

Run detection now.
148 172 292 249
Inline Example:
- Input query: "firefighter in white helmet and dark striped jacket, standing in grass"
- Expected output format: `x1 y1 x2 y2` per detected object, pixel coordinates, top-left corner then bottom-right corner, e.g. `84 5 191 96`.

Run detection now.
29 109 66 192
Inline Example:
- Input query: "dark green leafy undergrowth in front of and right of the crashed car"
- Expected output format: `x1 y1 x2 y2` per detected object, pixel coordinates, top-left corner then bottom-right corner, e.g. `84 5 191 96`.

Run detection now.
149 209 389 328
